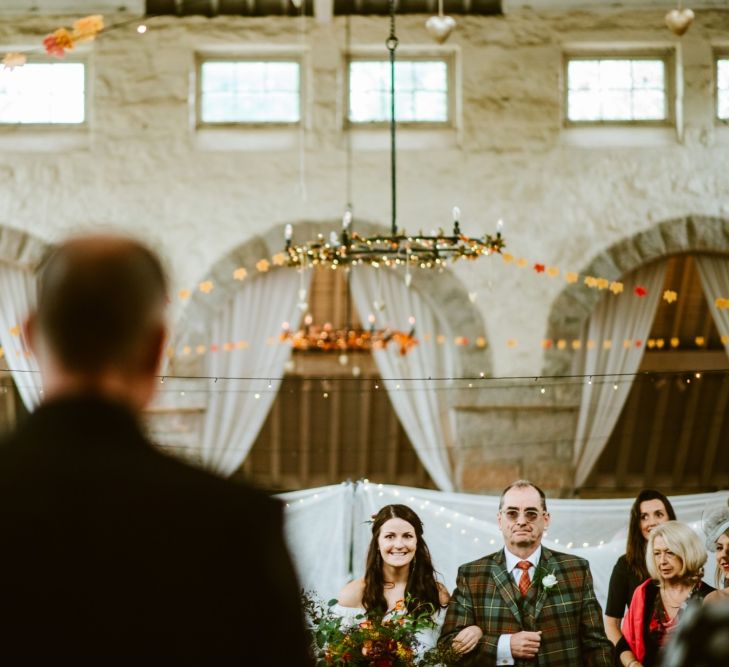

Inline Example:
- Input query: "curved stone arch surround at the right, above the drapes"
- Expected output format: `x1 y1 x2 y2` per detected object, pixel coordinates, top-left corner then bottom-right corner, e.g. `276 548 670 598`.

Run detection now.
542 215 729 375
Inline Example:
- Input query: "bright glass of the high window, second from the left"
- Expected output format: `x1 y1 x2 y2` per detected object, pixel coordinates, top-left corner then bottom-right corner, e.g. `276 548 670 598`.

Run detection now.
200 61 301 123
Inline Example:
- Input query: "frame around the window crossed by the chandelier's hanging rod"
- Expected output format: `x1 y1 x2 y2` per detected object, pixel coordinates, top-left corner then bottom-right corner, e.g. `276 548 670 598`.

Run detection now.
342 50 458 130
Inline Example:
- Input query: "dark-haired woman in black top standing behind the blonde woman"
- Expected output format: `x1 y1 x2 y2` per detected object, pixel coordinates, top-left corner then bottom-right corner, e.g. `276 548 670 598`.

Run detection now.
605 489 676 644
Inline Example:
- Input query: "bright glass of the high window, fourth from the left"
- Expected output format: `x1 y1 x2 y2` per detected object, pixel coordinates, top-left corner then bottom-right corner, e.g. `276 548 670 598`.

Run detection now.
567 58 668 122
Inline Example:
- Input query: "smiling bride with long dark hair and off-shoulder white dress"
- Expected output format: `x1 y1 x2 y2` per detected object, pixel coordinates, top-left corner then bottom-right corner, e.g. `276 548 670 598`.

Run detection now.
338 505 450 657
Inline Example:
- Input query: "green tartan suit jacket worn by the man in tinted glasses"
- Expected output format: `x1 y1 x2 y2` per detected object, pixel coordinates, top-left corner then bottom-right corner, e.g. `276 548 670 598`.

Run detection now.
440 546 613 667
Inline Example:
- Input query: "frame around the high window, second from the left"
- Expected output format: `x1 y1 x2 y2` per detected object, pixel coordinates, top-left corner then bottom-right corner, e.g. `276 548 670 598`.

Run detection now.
194 51 306 130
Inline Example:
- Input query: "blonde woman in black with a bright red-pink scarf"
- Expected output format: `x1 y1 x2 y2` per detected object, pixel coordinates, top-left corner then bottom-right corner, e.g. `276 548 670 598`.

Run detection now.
616 521 714 667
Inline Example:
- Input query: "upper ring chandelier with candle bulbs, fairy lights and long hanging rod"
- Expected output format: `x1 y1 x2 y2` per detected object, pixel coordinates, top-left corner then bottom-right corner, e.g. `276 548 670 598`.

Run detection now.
285 0 505 269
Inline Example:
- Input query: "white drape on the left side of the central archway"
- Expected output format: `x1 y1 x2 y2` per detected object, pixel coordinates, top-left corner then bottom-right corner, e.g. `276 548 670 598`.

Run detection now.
196 269 311 477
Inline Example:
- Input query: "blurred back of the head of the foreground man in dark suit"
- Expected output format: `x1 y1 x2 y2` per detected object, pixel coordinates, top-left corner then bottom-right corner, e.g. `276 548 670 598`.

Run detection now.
36 236 167 375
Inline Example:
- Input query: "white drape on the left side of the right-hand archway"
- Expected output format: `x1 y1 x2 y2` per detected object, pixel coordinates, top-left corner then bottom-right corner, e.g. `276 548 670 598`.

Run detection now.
573 261 666 486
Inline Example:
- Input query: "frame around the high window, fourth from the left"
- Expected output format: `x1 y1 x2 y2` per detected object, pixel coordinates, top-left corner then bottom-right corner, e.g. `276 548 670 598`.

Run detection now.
562 48 676 128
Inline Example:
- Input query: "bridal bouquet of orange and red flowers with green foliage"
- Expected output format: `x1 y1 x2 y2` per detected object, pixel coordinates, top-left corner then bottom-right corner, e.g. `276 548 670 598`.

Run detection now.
303 593 458 667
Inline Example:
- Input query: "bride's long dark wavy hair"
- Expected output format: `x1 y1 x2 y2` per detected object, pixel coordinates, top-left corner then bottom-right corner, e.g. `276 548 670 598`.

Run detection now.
362 505 442 615
